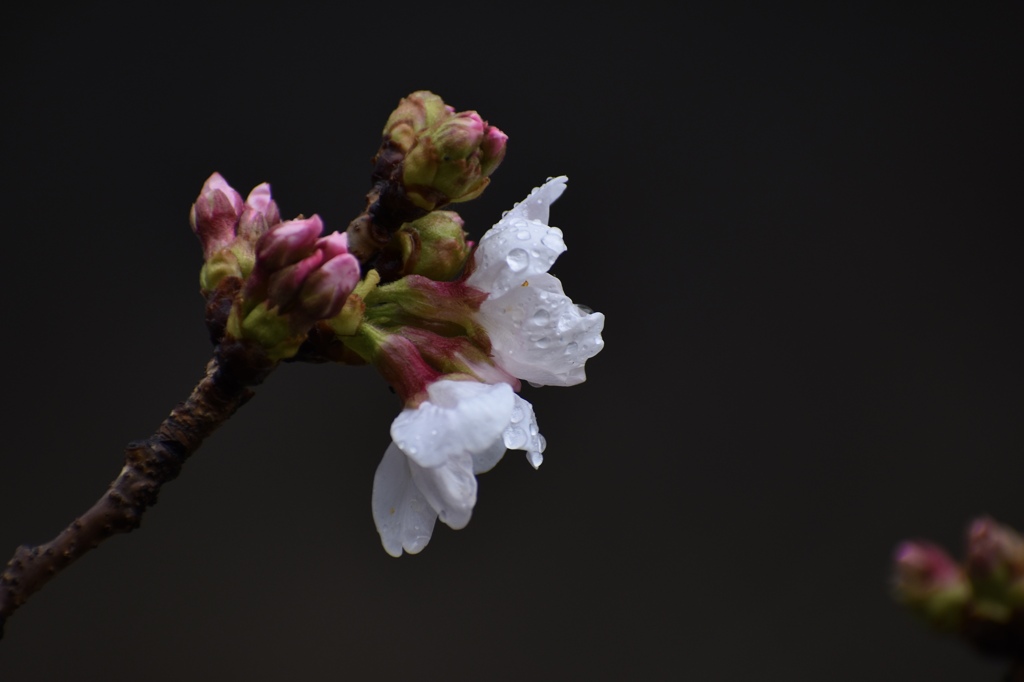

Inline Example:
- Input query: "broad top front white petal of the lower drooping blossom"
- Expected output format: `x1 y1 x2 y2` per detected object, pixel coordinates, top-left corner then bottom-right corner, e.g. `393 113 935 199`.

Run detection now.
391 379 514 468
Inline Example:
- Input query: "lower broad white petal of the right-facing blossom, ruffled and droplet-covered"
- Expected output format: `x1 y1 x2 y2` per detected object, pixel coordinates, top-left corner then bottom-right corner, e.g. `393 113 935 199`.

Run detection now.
477 273 604 386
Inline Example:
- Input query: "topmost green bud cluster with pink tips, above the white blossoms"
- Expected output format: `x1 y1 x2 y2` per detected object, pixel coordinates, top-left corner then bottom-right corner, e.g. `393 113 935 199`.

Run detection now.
384 90 508 211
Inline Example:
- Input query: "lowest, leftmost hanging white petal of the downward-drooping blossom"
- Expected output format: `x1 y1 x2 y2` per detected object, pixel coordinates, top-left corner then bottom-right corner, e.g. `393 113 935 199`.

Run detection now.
371 442 437 556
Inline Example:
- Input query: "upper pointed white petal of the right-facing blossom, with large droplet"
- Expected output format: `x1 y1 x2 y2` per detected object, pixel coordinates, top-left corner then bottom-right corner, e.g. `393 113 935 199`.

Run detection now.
466 176 565 296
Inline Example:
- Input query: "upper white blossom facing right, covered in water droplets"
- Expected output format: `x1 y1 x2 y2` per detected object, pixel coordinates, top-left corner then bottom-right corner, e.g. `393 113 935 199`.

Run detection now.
466 175 604 386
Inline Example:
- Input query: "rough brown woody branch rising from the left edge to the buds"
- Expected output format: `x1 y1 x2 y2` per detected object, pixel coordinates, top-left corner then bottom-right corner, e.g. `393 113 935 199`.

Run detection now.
0 346 271 637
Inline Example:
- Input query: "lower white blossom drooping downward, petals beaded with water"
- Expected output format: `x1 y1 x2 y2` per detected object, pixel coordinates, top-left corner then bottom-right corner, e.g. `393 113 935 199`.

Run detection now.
372 379 544 556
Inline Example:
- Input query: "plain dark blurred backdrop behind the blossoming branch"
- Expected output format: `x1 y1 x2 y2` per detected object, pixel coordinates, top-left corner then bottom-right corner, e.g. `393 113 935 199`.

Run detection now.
0 2 1024 682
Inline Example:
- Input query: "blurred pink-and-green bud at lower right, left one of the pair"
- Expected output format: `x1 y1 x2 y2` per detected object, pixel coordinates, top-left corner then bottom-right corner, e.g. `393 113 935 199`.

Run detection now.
893 541 971 630
